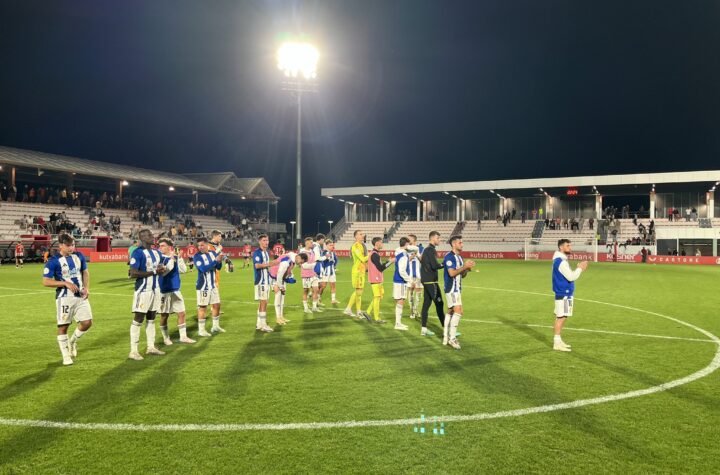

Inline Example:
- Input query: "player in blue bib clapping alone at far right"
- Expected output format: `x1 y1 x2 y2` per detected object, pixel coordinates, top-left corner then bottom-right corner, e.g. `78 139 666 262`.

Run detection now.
552 239 587 351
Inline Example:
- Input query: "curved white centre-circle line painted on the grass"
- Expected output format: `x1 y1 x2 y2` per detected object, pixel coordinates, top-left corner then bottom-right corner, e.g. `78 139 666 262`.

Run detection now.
0 287 720 432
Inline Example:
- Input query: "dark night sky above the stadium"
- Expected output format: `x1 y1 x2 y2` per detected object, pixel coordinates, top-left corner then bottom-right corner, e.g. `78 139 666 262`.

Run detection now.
0 0 720 230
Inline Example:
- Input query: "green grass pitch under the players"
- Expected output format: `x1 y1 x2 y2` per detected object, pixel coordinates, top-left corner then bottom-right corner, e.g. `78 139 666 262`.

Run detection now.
0 261 720 474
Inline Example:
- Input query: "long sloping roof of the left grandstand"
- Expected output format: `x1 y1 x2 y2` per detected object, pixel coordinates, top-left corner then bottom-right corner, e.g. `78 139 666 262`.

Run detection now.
0 146 279 200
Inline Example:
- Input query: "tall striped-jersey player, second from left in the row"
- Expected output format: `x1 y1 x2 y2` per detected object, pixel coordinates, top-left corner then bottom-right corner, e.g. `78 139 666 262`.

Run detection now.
128 229 166 361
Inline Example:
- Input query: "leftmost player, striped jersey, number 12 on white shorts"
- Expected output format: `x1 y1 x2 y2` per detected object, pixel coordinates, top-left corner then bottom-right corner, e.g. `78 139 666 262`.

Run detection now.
43 234 92 366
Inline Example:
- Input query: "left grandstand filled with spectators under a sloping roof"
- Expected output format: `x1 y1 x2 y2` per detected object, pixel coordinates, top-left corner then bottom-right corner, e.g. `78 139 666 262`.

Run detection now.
0 147 286 261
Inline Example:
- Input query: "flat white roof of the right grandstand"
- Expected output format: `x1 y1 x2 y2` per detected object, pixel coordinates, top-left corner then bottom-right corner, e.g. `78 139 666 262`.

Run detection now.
321 170 720 202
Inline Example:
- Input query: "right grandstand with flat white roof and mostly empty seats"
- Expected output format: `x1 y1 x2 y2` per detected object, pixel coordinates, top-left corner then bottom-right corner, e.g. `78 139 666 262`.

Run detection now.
321 170 720 263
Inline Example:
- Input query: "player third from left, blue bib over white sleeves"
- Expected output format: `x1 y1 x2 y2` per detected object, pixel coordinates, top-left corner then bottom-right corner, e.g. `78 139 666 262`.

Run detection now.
158 238 195 346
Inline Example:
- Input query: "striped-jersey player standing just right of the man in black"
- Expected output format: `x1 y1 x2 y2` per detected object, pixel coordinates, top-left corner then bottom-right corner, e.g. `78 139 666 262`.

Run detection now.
443 235 475 350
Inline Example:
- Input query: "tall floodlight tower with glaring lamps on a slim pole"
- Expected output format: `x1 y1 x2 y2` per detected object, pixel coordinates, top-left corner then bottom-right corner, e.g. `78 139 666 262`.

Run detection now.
277 41 320 245
